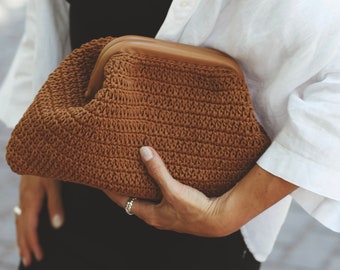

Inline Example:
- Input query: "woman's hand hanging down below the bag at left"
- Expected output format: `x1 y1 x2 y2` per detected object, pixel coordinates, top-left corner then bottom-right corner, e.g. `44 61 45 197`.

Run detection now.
16 175 64 266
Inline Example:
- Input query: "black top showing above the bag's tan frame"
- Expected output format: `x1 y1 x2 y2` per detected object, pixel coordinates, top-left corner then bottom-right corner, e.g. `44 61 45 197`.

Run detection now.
67 0 172 49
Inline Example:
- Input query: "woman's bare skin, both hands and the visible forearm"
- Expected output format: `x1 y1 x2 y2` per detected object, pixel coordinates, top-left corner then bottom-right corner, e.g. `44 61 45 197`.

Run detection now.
16 147 297 266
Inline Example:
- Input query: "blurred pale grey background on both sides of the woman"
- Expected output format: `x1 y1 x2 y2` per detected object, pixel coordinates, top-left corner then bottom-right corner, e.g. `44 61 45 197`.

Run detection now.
0 0 340 270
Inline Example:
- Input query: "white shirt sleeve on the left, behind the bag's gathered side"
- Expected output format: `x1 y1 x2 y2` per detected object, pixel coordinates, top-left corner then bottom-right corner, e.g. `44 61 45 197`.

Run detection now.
0 0 70 128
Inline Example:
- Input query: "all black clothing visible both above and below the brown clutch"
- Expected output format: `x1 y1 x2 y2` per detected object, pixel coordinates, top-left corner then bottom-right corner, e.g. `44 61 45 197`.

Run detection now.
20 0 260 270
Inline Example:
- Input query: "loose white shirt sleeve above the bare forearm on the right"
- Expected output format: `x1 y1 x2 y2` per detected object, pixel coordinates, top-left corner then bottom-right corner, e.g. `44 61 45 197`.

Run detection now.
258 45 340 232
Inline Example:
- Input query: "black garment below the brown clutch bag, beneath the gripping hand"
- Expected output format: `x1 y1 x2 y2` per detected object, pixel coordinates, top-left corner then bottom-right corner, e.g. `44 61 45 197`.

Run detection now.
20 183 260 270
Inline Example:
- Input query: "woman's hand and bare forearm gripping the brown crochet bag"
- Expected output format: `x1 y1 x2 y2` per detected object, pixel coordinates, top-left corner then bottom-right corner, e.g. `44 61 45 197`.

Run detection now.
105 147 296 237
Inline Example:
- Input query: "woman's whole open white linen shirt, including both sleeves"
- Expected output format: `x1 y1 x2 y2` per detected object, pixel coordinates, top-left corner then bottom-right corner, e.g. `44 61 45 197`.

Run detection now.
0 0 340 261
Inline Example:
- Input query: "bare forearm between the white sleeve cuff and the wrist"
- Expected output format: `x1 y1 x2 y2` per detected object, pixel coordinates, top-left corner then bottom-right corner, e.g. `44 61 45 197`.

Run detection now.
219 165 297 235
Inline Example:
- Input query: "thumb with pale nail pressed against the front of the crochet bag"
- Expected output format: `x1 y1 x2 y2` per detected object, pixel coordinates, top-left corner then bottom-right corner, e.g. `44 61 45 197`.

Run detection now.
139 146 180 195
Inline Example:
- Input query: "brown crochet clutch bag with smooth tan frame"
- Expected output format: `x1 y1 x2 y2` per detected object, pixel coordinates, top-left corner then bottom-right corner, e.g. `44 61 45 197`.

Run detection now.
6 36 270 200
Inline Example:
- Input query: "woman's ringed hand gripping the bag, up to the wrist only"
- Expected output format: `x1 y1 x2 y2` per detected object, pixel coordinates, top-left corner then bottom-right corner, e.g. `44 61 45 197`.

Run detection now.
104 147 234 236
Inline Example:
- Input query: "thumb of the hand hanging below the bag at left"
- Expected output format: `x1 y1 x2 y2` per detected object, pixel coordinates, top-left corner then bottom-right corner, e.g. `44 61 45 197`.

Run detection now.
47 179 64 229
